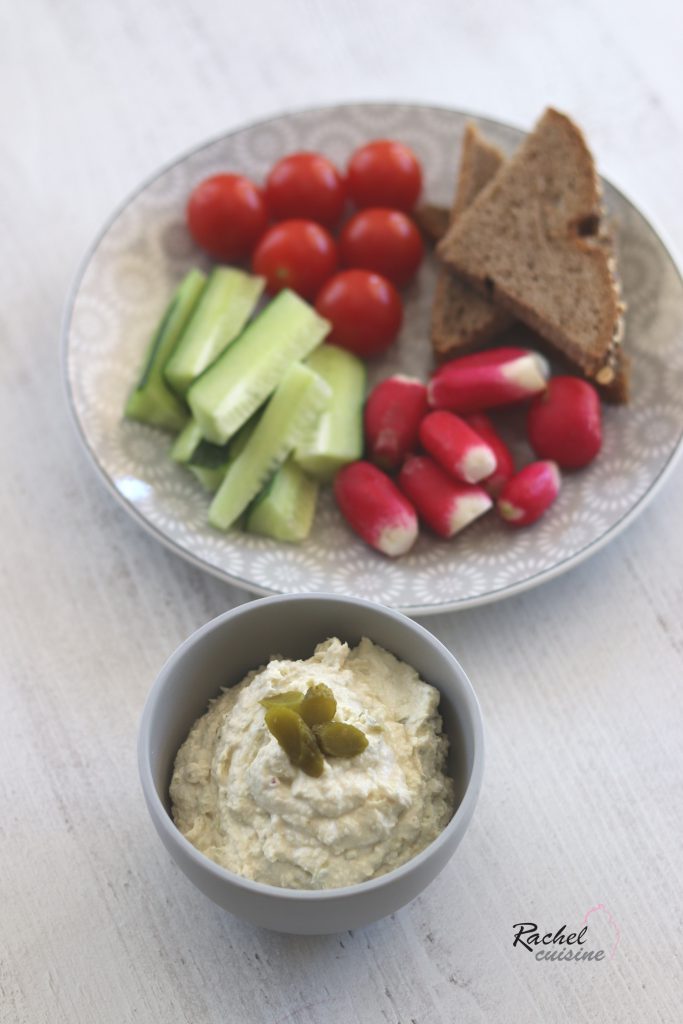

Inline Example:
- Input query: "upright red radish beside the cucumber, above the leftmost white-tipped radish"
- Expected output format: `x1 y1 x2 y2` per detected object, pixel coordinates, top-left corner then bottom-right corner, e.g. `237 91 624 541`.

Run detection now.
364 375 427 472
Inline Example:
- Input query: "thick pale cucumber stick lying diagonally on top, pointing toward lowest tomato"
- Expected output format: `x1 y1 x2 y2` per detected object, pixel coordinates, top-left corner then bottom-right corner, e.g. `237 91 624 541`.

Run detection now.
187 290 330 444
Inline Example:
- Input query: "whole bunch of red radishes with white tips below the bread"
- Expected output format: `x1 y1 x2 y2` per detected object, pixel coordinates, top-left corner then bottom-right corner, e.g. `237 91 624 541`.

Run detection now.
335 348 602 557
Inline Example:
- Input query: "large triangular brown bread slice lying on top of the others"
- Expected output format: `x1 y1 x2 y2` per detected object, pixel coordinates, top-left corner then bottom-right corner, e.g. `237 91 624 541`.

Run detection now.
437 109 623 386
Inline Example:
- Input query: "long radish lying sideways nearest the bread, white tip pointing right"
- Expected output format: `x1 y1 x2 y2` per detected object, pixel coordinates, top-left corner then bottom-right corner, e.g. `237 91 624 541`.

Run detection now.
427 348 549 414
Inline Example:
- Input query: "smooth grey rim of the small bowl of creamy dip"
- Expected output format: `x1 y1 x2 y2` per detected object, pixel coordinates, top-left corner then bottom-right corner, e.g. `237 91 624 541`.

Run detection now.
137 591 484 902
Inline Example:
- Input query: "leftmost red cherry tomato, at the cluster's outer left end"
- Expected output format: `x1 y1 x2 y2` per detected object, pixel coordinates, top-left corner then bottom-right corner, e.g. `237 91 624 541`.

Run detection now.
186 174 268 263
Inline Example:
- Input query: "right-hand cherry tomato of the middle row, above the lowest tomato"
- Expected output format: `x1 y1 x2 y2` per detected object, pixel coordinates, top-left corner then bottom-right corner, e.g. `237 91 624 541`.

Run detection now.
339 210 423 288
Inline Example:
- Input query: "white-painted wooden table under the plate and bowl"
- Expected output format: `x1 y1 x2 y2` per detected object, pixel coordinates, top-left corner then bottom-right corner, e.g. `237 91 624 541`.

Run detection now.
0 0 683 1024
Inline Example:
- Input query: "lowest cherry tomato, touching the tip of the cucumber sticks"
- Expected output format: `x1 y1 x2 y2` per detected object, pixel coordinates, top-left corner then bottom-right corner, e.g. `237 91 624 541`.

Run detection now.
315 270 403 359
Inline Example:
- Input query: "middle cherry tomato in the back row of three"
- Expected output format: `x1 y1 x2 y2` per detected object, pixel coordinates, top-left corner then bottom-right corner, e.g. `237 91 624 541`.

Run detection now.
265 153 346 227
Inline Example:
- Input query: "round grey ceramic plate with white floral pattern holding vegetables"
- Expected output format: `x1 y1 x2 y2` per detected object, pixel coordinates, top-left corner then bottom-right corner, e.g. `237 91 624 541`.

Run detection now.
65 103 683 613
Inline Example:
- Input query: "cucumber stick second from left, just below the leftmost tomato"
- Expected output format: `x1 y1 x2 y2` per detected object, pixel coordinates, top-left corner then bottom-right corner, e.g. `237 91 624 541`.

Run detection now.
164 266 264 395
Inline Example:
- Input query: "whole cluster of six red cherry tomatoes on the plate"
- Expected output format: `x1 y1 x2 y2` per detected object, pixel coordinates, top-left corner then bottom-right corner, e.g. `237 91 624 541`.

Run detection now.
186 139 423 358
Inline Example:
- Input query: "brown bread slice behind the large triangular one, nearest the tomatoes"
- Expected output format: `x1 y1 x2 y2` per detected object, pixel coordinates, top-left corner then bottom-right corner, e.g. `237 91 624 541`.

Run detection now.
430 122 512 361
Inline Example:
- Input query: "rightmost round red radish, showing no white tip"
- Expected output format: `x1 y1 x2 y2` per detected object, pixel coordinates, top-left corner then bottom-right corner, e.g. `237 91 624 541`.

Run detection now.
526 377 602 469
